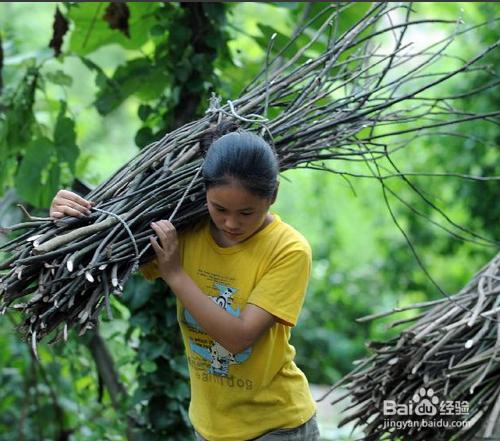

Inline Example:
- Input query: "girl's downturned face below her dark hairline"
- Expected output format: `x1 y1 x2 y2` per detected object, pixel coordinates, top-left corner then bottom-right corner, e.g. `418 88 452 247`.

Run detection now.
207 180 274 243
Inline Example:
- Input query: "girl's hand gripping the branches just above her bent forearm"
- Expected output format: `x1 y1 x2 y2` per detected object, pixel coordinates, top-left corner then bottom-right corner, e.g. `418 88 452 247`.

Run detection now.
150 220 182 283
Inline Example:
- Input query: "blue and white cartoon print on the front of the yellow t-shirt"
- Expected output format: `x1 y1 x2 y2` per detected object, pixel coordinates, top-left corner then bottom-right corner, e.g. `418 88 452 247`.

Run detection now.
184 283 252 377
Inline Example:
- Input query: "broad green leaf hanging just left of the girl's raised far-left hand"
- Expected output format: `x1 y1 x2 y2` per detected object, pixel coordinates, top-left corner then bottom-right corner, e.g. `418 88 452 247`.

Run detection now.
15 137 60 207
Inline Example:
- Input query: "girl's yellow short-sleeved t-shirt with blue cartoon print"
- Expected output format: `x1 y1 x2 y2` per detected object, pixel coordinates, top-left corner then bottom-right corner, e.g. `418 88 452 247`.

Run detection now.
141 214 316 441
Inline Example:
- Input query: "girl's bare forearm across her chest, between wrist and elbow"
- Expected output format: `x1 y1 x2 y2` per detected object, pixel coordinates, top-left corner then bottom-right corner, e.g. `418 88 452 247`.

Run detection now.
163 271 252 354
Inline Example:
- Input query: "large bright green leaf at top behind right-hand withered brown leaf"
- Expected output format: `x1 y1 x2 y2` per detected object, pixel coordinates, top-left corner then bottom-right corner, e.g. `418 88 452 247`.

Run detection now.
68 2 158 55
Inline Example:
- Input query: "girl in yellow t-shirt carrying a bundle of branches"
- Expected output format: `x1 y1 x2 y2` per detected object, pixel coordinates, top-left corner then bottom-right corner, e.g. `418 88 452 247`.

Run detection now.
51 125 319 441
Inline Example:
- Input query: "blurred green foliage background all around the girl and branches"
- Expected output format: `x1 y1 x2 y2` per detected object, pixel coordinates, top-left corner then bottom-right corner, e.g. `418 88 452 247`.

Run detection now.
0 2 500 441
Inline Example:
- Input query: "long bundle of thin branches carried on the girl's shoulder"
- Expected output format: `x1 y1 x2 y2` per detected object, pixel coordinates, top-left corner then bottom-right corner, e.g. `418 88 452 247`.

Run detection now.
0 3 500 353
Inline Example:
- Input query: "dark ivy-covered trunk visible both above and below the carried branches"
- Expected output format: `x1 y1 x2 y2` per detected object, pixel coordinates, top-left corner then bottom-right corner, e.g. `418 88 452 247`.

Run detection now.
124 3 228 441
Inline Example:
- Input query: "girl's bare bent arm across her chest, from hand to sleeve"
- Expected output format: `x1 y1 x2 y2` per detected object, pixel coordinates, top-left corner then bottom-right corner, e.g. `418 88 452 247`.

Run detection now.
151 220 276 354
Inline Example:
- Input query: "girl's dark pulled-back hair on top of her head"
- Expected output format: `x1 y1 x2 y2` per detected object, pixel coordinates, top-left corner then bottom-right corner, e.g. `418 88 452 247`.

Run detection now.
202 118 279 198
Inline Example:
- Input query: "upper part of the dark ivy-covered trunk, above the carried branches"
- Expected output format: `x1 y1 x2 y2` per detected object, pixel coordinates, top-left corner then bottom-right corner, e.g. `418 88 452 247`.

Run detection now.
135 3 230 147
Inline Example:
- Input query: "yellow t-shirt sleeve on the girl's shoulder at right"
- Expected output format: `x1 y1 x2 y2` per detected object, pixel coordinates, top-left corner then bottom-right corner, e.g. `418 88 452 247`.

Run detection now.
248 249 312 326
